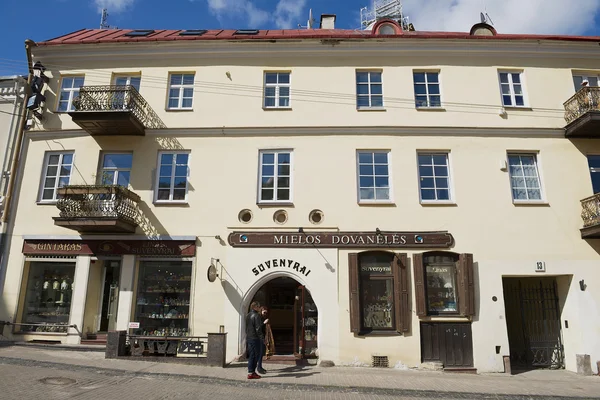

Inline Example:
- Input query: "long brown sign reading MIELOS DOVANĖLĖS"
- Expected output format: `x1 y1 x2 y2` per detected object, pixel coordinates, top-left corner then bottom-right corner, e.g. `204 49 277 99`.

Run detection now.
228 231 454 248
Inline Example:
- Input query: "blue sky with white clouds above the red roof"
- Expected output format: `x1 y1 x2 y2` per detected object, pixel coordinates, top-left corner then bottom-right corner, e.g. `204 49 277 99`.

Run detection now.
0 0 600 76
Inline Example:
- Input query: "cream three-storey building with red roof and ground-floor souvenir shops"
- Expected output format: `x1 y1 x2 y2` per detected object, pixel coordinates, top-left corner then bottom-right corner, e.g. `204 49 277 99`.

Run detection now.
0 20 600 372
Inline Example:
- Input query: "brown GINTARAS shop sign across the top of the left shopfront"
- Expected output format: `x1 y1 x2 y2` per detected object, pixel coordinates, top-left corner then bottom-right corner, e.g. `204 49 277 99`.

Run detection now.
23 240 196 257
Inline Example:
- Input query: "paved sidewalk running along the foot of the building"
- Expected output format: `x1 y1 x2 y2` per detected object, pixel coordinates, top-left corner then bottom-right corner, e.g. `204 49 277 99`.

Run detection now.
0 346 600 398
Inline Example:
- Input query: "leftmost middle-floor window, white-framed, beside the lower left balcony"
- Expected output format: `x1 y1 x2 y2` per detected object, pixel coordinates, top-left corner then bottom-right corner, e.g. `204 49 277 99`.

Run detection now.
40 152 73 202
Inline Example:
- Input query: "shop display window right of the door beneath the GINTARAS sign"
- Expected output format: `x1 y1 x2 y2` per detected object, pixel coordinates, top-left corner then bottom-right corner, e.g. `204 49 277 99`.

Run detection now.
135 261 192 336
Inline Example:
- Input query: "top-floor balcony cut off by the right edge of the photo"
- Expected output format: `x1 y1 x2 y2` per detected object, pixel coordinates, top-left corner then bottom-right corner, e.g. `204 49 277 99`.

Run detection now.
564 86 600 138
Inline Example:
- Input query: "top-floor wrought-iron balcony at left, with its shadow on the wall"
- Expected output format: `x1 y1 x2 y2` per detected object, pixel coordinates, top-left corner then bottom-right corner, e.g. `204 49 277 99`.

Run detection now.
69 85 166 136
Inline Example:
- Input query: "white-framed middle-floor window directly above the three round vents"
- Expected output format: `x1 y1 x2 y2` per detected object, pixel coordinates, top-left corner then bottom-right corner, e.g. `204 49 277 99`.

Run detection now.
258 150 292 203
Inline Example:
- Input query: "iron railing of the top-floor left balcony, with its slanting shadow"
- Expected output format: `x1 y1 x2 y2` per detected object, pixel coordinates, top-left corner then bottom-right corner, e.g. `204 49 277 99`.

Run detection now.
73 85 166 129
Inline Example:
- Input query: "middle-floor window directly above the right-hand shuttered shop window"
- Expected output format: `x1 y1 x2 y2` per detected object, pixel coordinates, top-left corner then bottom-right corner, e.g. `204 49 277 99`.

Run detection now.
417 153 450 202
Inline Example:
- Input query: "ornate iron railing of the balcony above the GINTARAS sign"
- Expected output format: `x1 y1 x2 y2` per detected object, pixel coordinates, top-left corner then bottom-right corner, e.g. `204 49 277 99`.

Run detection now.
56 185 140 224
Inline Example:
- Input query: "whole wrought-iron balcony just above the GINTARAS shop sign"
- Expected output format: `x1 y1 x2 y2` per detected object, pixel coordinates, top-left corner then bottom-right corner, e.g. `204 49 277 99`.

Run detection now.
53 185 140 233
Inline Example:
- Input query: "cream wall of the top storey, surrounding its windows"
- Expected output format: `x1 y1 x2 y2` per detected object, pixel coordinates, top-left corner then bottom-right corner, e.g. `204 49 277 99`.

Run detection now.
29 48 598 130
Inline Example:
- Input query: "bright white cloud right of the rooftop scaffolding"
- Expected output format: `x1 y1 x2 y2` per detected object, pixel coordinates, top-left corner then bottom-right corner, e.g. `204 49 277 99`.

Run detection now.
403 0 600 35
